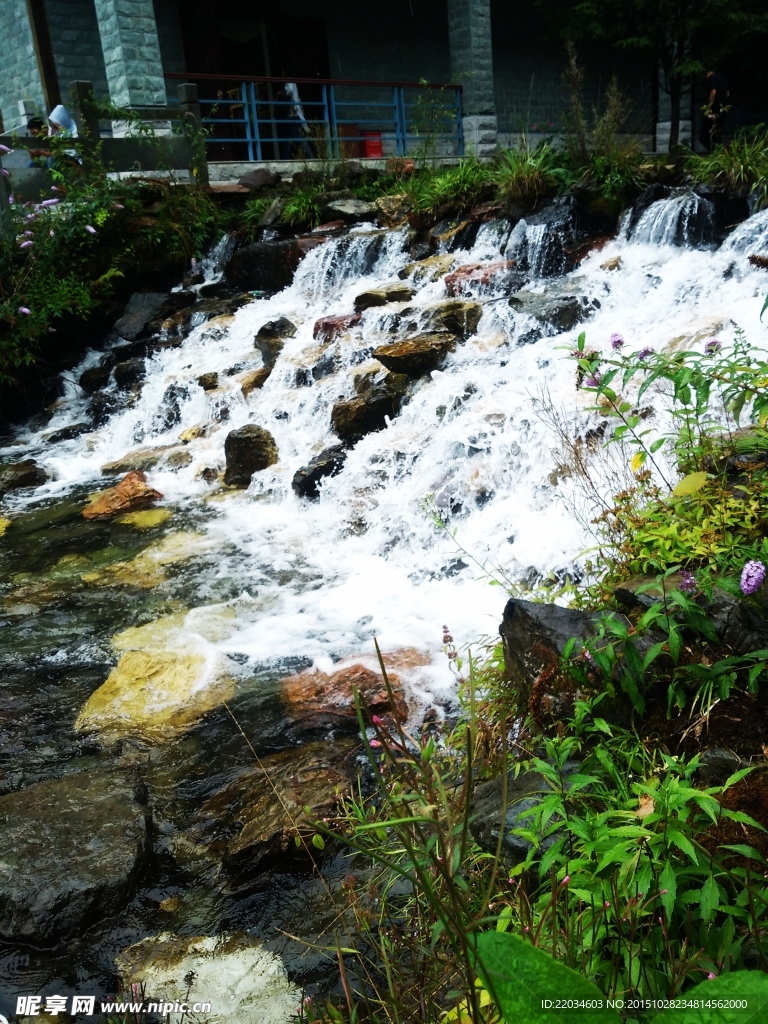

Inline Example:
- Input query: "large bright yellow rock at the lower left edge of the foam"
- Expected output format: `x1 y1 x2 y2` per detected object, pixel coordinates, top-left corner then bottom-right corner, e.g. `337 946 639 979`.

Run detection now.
75 643 234 743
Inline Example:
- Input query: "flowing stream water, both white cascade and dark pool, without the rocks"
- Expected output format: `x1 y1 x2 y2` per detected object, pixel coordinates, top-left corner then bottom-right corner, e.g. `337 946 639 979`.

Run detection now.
0 195 768 1014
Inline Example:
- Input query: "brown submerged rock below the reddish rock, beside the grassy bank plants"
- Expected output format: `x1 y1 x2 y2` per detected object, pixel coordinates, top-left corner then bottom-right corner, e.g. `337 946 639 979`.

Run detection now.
193 739 358 873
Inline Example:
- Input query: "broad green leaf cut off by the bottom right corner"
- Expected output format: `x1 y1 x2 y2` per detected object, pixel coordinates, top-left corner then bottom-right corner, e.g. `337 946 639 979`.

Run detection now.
653 971 768 1024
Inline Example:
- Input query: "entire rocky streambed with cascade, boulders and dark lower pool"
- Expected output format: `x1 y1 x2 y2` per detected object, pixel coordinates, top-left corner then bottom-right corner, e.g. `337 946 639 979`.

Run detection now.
0 186 768 1022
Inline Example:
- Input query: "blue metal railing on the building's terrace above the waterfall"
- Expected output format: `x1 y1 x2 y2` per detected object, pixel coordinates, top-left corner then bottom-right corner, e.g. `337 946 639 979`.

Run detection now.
167 73 464 161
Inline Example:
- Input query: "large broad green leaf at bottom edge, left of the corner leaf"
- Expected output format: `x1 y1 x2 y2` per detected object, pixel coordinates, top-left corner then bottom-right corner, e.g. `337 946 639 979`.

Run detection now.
476 932 621 1024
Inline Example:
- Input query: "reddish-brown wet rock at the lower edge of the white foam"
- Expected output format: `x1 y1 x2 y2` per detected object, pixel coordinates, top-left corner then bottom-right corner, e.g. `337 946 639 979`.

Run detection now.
281 662 408 728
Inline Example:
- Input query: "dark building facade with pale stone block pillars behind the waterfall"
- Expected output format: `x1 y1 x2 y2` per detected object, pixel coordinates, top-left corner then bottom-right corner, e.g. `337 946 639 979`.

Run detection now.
0 0 654 155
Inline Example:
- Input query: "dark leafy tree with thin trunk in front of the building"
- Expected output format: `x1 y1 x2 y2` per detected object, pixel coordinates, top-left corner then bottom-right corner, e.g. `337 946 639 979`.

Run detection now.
538 0 768 146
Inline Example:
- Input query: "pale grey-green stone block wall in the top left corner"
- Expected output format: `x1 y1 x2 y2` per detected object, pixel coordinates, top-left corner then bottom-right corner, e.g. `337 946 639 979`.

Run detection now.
0 0 43 131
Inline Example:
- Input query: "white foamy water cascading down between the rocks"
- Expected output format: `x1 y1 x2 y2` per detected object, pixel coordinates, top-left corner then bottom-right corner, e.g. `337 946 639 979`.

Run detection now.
4 197 768 698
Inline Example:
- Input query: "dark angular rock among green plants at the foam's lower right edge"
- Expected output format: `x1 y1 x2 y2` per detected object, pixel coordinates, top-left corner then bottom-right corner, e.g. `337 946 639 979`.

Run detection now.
499 597 593 696
